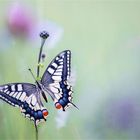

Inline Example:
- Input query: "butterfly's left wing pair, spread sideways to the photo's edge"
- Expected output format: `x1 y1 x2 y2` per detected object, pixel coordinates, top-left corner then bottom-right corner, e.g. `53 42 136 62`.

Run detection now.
0 83 47 123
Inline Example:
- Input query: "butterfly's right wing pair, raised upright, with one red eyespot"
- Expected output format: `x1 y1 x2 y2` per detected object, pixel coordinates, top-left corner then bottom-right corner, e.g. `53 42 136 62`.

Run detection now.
41 50 72 110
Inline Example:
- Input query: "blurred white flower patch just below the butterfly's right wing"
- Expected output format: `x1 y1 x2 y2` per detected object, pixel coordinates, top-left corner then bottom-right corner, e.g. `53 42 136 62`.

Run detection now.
55 110 69 129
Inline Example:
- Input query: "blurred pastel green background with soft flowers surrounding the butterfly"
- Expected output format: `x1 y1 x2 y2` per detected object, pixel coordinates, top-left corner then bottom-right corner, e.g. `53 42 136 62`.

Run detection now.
0 0 140 140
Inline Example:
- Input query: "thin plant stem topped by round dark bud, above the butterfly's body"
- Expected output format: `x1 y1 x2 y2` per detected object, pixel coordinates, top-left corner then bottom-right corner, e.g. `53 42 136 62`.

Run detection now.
37 31 49 77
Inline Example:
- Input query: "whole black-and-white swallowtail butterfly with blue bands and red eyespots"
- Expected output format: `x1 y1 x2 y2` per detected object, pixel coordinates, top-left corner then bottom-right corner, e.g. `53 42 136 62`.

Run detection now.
0 31 76 125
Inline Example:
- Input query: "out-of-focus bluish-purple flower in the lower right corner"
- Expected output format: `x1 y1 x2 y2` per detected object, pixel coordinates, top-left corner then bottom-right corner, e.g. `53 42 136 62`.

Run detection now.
106 97 137 130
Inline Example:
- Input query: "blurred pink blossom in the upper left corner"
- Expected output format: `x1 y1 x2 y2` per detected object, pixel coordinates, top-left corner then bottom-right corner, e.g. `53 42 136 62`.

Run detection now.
7 3 34 37
